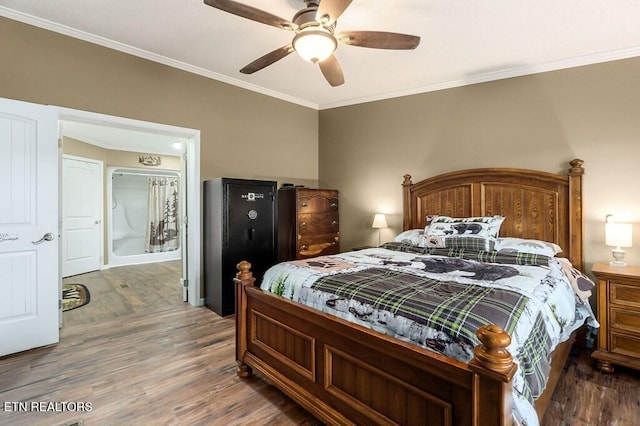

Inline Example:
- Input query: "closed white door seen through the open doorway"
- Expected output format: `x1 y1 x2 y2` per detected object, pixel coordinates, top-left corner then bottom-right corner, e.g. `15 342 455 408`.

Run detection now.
62 156 103 277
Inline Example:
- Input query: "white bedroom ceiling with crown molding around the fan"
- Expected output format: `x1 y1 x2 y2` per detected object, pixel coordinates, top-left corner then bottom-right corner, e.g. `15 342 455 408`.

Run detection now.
0 0 640 109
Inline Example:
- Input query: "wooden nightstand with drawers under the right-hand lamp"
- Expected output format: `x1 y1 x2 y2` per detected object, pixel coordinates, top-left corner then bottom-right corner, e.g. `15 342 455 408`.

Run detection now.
591 263 640 373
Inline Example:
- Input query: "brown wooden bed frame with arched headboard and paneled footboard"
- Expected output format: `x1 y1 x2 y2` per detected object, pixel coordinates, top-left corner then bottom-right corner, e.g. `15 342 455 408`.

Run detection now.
235 159 584 426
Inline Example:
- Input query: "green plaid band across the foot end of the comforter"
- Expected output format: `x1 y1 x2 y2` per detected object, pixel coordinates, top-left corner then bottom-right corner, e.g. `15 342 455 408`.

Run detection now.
311 268 528 350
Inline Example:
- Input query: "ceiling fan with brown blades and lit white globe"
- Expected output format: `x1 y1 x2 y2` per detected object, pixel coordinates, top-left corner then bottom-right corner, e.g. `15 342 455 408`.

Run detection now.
204 0 420 87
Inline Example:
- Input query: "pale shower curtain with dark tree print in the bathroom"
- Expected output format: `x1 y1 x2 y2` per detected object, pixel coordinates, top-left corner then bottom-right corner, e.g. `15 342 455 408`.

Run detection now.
145 176 180 253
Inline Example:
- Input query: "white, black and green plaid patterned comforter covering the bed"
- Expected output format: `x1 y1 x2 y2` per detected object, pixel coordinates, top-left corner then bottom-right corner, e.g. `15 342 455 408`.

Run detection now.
262 243 587 425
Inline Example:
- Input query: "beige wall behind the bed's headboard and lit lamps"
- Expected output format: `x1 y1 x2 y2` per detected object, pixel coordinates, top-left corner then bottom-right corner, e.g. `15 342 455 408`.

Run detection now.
319 58 640 272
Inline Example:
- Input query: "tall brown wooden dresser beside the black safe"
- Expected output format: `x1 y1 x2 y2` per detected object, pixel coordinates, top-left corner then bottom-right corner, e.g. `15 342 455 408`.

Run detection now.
278 187 340 261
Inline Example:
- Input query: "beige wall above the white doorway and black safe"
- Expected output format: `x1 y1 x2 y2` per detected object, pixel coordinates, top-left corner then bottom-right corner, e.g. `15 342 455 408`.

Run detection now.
0 17 318 186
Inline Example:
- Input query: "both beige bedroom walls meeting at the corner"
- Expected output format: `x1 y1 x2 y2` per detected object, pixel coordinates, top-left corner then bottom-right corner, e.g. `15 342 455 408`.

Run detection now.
0 18 640 276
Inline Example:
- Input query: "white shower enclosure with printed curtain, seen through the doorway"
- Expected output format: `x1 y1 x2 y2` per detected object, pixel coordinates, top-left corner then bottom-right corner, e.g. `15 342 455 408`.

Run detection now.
107 167 181 266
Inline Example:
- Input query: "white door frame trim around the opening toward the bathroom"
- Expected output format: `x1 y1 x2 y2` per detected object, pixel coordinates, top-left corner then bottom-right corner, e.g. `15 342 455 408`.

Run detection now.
59 108 203 306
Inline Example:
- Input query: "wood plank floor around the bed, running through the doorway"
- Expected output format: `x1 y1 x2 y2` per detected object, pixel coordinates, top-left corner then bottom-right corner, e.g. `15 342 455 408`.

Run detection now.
0 262 640 426
